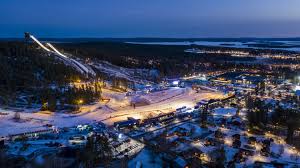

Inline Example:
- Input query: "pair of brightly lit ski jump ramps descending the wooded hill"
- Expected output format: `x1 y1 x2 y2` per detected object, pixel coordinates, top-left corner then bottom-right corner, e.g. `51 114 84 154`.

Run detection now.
25 32 96 77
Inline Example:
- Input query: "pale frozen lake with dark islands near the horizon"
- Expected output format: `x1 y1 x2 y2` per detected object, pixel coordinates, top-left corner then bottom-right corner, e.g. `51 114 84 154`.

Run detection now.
126 41 300 52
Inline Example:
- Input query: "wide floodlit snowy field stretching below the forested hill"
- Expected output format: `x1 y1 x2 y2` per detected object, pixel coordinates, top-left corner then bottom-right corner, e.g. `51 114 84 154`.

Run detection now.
0 88 224 136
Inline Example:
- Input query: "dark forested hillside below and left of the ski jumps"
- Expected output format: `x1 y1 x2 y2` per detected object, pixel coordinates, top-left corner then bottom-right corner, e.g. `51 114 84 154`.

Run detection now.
0 42 101 110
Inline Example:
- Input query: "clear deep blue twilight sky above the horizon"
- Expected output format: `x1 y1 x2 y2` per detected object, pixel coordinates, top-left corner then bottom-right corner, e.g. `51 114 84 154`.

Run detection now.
0 0 300 38
